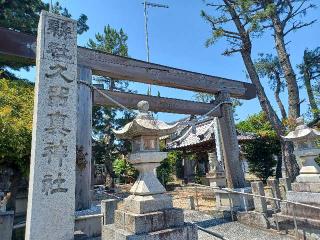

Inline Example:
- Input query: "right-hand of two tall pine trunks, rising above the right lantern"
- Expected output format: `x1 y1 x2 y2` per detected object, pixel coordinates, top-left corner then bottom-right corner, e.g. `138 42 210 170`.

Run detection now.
265 0 300 119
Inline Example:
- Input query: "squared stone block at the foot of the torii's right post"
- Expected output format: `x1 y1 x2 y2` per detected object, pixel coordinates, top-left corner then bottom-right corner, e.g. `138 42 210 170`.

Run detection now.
214 187 254 211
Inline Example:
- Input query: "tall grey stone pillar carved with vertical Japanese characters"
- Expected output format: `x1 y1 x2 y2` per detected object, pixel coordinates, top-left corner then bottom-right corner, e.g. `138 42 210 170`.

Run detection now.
25 11 77 240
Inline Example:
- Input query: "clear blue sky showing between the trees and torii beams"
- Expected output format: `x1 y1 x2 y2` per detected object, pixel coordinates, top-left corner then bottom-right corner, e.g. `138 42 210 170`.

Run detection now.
15 0 320 121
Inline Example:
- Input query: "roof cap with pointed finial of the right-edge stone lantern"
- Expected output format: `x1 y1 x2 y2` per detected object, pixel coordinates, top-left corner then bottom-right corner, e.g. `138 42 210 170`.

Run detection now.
283 117 320 141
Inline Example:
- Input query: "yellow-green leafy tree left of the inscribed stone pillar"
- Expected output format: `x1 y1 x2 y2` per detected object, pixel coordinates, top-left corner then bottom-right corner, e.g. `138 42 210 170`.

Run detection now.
0 76 33 208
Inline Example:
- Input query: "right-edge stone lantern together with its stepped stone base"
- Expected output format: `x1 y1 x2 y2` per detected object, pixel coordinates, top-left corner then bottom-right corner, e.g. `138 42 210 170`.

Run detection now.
281 118 320 221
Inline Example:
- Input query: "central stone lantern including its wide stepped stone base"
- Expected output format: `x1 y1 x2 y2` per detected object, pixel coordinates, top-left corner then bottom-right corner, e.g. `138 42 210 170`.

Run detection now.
102 101 198 240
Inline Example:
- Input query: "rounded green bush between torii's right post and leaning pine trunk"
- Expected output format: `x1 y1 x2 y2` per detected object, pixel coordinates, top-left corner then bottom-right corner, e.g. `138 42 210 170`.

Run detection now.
237 112 281 181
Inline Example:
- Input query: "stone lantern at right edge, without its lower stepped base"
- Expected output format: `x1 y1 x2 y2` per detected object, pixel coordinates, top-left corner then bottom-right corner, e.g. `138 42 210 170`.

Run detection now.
283 117 320 182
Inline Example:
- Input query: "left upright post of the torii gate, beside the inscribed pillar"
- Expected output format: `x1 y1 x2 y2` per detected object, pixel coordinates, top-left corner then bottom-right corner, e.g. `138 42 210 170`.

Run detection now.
76 66 92 210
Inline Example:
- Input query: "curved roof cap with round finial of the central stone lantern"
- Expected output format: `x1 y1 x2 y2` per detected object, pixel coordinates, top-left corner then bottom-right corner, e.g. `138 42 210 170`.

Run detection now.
113 101 178 139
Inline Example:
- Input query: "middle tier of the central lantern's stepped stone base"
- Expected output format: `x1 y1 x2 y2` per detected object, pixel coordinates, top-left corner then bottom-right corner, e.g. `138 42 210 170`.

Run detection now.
115 208 184 234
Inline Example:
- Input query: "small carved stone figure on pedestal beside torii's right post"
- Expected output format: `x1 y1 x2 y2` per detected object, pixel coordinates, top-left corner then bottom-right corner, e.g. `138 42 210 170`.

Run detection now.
206 152 226 188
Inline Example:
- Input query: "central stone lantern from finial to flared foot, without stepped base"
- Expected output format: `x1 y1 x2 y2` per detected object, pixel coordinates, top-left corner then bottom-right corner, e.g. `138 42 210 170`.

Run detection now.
114 101 177 196
